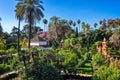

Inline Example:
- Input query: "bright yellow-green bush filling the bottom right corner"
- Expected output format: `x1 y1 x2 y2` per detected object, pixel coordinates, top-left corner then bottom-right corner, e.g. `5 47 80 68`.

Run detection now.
93 64 120 80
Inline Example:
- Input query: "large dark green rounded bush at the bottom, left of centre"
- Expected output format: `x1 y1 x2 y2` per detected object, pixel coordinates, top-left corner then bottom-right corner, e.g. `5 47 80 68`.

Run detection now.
22 62 62 80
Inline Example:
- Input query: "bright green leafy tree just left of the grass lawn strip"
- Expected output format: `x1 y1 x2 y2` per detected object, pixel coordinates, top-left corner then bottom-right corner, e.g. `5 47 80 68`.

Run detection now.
58 49 78 73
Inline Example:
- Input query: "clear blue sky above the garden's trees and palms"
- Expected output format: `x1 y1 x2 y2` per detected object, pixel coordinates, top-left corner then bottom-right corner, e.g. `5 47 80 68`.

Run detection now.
0 0 120 33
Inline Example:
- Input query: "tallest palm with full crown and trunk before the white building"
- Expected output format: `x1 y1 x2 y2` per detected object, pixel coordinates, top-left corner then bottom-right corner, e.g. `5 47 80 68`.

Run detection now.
17 0 44 48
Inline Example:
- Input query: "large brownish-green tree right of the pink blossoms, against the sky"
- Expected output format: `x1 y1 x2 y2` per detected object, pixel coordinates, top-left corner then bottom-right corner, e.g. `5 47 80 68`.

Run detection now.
49 16 72 41
